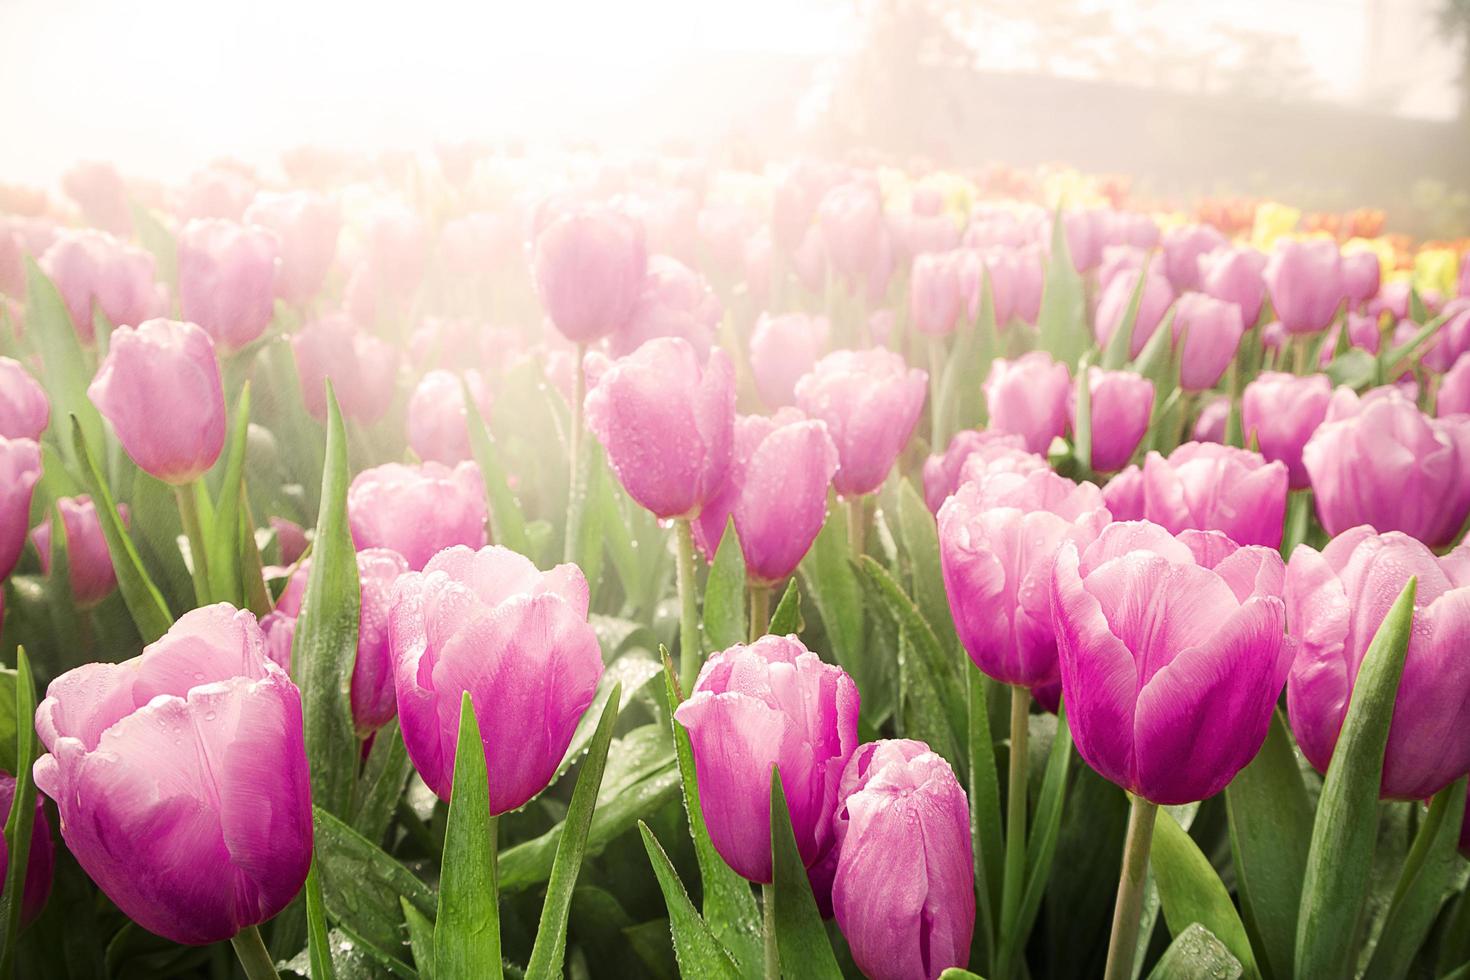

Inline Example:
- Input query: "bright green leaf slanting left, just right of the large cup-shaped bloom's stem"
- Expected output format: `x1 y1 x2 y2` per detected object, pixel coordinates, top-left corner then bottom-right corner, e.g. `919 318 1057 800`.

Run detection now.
1150 807 1264 977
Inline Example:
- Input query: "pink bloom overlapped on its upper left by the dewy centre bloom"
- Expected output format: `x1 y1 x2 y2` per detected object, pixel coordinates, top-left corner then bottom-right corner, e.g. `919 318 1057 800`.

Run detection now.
694 408 838 585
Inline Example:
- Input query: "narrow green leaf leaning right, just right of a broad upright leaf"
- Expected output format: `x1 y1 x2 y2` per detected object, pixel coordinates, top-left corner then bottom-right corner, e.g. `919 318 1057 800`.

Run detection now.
526 688 622 980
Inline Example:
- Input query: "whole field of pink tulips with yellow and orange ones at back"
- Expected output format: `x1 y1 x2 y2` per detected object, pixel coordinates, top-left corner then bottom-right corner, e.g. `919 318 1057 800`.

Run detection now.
0 160 1470 980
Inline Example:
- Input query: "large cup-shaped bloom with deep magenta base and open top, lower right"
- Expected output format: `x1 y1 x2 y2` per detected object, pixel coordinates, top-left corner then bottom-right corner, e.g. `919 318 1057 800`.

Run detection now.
1051 522 1292 804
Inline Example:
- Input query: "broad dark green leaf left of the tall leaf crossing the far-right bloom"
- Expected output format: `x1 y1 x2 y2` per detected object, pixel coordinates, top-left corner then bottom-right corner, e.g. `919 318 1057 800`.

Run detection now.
1225 711 1311 977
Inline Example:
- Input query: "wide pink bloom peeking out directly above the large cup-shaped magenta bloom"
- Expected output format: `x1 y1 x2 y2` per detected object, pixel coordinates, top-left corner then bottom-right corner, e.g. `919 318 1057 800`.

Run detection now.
1144 442 1288 548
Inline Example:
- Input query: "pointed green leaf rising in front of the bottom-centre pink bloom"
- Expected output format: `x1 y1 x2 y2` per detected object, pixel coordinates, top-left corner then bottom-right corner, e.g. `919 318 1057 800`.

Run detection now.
767 767 842 980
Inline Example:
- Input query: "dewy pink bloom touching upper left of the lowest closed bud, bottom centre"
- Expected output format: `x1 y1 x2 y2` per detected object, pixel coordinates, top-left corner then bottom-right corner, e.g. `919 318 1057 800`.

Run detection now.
673 635 858 882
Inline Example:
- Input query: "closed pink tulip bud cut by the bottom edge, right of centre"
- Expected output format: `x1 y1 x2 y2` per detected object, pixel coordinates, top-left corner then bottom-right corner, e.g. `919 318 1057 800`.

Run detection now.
832 739 975 980
